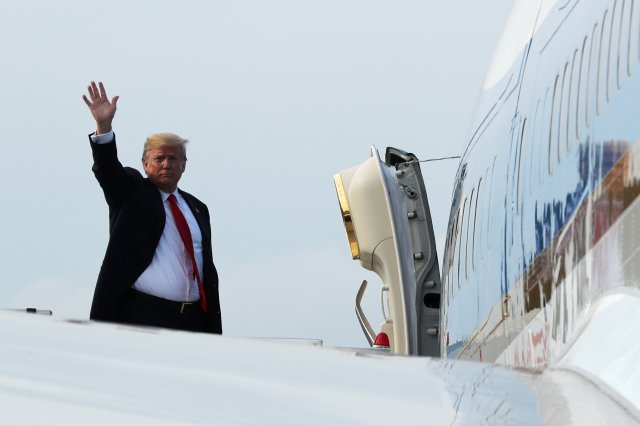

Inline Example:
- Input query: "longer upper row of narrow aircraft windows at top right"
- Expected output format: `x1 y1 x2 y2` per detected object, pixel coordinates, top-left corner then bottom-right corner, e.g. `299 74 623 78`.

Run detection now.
516 0 640 207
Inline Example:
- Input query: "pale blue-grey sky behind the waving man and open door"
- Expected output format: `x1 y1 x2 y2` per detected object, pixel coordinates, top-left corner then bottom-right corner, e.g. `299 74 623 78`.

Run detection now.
0 0 512 347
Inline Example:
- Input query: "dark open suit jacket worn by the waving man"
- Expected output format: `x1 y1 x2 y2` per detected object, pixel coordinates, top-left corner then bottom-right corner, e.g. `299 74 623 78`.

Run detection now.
90 135 222 333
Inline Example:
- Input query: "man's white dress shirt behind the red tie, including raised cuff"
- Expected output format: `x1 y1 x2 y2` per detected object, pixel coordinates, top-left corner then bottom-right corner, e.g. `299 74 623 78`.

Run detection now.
91 131 203 302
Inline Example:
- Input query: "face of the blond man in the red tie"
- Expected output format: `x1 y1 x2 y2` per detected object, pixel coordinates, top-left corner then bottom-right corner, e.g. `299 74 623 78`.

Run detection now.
142 146 187 192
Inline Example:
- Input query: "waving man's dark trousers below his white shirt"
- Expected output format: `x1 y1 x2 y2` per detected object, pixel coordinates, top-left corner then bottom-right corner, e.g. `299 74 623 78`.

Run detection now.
117 289 205 332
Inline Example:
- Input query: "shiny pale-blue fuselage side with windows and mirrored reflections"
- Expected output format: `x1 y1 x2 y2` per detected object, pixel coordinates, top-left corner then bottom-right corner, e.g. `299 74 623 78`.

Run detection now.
441 0 640 366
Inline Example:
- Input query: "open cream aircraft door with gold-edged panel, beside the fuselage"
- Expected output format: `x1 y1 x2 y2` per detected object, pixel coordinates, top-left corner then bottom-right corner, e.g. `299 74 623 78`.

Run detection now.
334 147 442 356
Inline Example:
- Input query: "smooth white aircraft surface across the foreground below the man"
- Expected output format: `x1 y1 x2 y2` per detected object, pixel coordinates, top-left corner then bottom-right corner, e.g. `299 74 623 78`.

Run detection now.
0 311 637 425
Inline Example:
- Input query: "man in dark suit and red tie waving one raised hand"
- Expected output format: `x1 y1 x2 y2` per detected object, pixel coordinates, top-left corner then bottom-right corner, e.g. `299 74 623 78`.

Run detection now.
83 82 222 334
